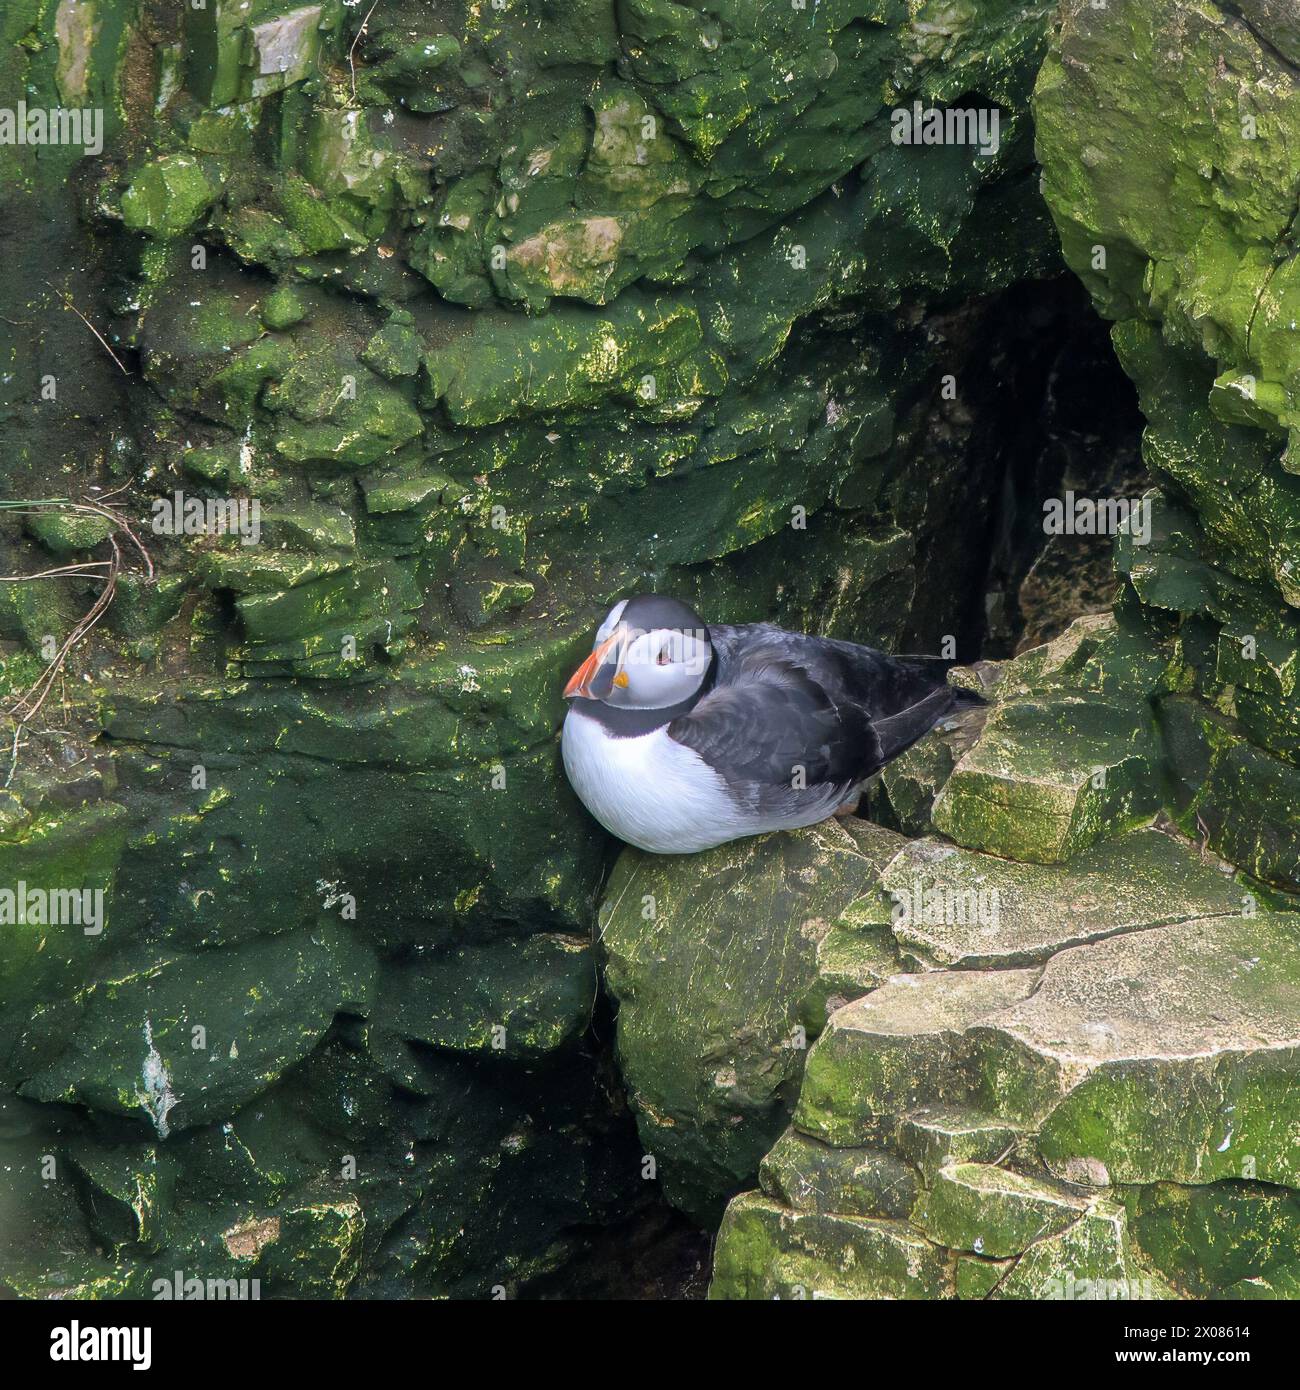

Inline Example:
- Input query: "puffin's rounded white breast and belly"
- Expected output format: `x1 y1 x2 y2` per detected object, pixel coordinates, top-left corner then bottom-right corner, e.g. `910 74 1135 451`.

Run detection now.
562 708 754 855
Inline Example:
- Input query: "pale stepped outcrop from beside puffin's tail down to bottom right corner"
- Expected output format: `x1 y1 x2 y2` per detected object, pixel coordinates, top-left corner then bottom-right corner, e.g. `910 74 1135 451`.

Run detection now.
700 619 1300 1298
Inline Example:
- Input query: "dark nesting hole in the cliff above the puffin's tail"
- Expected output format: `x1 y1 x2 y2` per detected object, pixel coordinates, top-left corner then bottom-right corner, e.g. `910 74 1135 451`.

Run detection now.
922 277 1147 659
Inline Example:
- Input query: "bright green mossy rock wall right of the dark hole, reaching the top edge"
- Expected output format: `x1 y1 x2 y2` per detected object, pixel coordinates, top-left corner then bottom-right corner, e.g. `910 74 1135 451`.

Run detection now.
1034 0 1300 891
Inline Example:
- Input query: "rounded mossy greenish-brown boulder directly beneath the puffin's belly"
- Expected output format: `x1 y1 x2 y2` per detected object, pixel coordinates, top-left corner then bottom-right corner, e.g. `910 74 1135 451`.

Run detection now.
598 820 898 1215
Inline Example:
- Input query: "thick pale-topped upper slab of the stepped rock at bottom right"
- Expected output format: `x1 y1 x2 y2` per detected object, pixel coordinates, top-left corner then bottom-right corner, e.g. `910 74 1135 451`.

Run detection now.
795 915 1300 1183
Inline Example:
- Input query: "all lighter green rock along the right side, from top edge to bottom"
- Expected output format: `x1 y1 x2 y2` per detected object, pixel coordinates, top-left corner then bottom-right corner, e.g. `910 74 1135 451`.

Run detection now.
642 0 1300 1300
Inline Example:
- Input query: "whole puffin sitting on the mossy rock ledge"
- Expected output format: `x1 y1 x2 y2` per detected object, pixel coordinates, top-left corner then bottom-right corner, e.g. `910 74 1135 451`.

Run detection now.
560 594 984 855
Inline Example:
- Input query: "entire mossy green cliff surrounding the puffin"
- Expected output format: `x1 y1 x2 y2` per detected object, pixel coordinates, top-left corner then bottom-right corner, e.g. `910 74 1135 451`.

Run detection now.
0 0 1300 1298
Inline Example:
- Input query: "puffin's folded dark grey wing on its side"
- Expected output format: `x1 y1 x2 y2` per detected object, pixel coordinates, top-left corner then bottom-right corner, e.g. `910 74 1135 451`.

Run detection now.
667 660 880 788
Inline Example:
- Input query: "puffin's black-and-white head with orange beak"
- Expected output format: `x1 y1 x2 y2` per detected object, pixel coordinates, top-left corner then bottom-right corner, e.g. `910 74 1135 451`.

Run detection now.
564 594 713 714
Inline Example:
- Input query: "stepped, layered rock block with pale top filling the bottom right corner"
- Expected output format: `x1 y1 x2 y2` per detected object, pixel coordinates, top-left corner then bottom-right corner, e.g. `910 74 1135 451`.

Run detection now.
713 906 1300 1298
